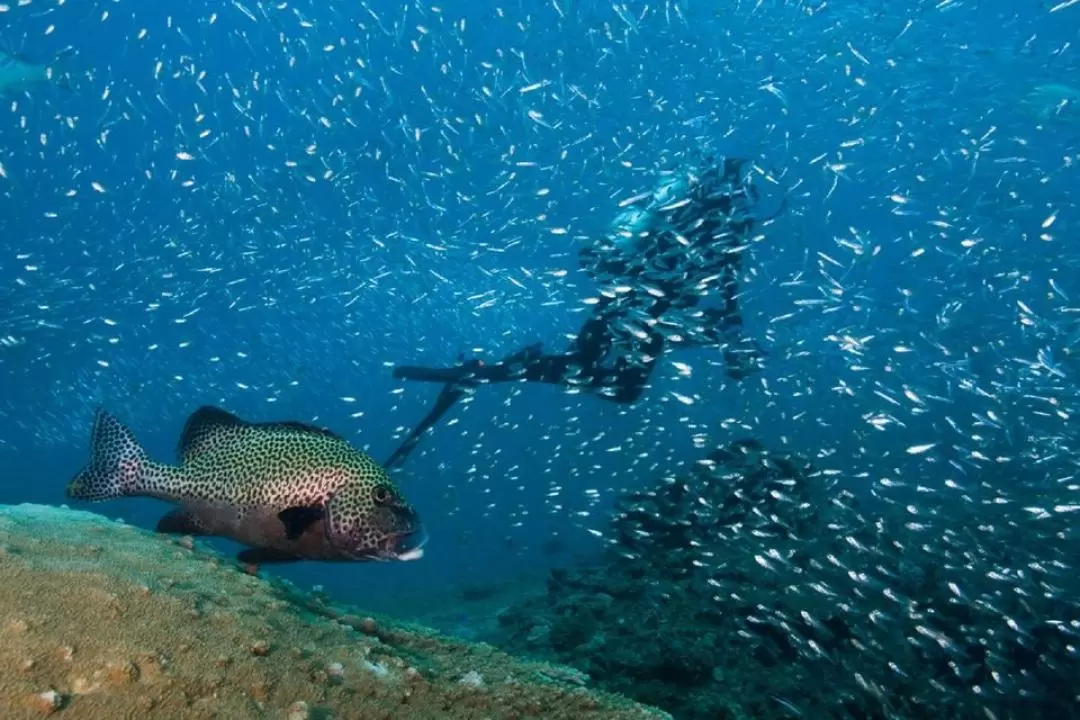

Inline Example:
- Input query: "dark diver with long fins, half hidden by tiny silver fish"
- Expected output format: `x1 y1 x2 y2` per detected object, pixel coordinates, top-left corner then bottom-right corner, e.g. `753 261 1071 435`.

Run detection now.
387 155 786 467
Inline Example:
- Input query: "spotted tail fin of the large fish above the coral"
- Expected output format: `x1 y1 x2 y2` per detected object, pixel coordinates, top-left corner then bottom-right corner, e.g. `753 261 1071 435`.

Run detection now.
67 408 153 502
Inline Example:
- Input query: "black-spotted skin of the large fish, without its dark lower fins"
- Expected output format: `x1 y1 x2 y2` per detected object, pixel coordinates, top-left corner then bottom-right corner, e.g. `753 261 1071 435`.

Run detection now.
63 408 418 555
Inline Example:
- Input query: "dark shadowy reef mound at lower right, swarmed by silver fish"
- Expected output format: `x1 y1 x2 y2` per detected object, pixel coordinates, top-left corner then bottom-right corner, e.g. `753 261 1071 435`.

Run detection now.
487 441 1080 720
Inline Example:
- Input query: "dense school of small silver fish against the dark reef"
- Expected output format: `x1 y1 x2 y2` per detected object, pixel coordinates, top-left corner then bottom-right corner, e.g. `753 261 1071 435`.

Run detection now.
605 441 1080 719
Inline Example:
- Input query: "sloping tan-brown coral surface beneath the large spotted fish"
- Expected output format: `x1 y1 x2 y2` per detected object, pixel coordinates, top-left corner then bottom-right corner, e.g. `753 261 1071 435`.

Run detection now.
0 505 667 720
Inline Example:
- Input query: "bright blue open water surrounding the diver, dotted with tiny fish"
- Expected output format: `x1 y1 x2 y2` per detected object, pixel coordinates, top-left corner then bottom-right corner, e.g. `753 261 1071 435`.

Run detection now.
0 0 1080 604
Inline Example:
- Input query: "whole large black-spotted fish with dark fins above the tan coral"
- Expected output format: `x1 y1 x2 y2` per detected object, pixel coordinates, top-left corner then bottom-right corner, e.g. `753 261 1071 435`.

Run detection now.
67 407 427 563
